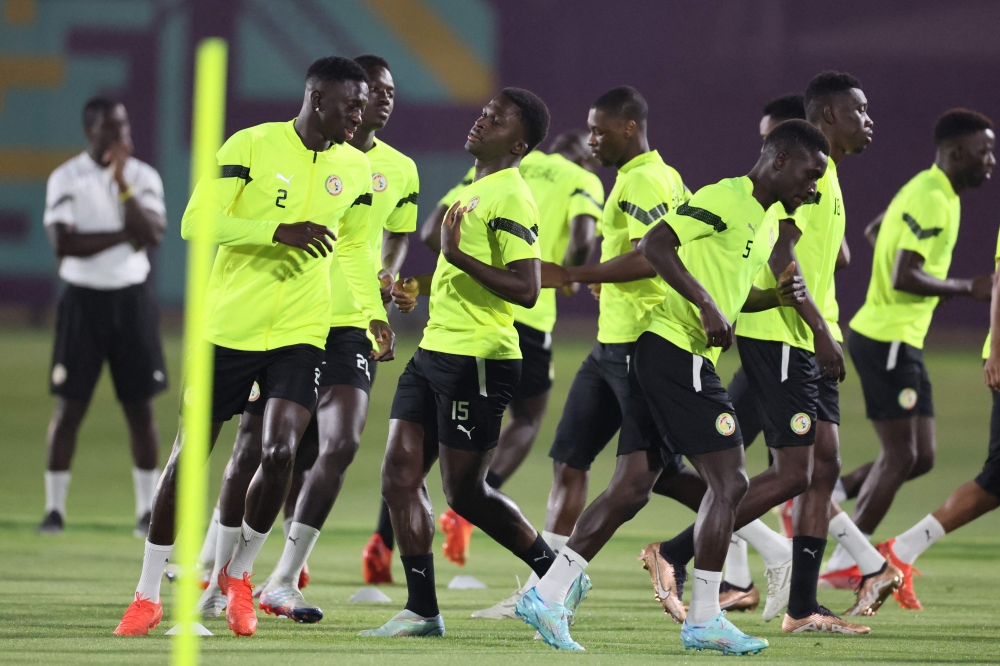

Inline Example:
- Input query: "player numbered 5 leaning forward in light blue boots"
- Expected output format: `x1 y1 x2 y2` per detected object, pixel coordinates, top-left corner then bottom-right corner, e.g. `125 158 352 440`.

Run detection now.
517 120 830 654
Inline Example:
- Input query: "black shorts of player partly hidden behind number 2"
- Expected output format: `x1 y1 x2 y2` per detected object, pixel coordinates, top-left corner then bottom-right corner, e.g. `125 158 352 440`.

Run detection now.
245 326 378 416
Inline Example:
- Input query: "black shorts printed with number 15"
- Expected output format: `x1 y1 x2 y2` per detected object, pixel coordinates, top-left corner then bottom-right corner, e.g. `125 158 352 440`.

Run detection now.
389 348 521 451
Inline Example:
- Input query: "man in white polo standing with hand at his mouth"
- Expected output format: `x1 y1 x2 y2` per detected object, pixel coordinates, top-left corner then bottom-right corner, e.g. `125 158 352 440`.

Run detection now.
38 97 167 538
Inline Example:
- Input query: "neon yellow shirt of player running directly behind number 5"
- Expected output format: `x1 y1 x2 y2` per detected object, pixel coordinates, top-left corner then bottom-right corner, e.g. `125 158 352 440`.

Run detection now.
737 160 844 351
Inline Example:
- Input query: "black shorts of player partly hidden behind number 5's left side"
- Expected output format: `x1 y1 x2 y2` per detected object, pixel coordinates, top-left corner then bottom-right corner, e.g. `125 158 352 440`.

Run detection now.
549 342 684 474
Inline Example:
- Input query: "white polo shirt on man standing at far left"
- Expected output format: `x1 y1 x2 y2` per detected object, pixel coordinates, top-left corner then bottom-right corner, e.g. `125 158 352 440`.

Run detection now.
43 152 166 289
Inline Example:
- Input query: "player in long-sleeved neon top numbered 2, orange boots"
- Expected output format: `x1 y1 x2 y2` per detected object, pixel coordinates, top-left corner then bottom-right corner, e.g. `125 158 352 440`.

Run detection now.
115 57 393 635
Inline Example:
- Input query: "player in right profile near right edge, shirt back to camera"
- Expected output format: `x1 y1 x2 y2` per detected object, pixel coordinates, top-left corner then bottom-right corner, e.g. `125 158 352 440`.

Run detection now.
828 109 995 596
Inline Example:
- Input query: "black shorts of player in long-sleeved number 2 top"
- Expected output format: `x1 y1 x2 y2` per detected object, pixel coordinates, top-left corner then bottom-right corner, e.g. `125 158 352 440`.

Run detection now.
212 344 323 423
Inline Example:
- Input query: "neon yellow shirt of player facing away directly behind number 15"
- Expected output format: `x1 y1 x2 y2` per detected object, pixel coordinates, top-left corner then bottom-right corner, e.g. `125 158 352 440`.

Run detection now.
511 150 604 333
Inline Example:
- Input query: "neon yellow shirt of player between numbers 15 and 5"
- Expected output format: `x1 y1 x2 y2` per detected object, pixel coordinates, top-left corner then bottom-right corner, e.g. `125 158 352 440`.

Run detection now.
597 150 691 344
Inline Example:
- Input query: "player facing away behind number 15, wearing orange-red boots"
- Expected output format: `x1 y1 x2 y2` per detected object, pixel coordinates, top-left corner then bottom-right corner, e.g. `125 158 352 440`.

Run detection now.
362 132 604 580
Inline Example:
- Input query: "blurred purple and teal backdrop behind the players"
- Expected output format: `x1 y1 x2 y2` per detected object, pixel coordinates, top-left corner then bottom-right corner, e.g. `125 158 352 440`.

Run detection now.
0 0 1000 332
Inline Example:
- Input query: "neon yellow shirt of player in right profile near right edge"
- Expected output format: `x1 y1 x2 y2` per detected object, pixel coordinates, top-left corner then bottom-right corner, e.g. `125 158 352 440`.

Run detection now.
851 165 962 349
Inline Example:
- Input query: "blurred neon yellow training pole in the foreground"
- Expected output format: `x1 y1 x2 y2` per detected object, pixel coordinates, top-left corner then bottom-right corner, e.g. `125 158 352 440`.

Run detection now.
173 38 228 666
